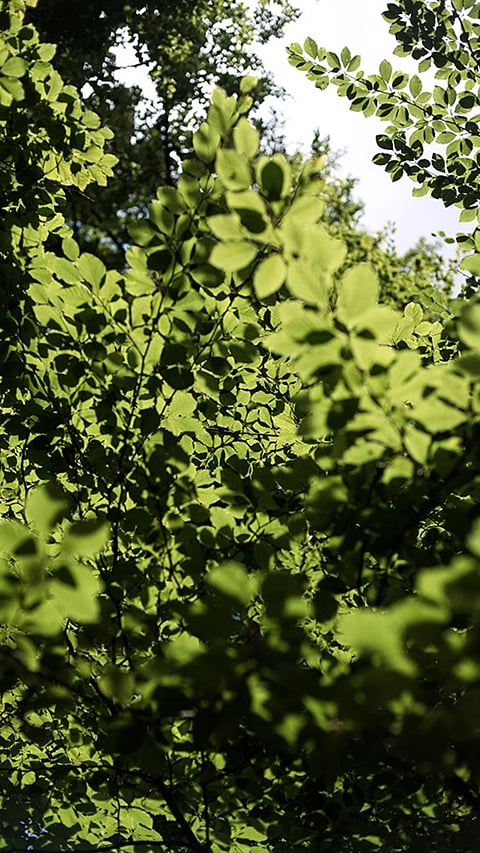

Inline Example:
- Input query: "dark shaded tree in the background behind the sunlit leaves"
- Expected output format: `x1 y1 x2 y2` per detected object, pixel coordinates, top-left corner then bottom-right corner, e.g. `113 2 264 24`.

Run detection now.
29 0 297 266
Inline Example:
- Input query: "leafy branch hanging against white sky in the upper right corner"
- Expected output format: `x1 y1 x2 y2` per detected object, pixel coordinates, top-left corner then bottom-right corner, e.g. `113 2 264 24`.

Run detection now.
288 0 480 280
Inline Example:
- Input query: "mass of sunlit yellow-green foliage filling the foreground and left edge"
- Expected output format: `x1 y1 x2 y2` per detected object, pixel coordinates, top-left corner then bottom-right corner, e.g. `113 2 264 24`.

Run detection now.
0 0 480 853
